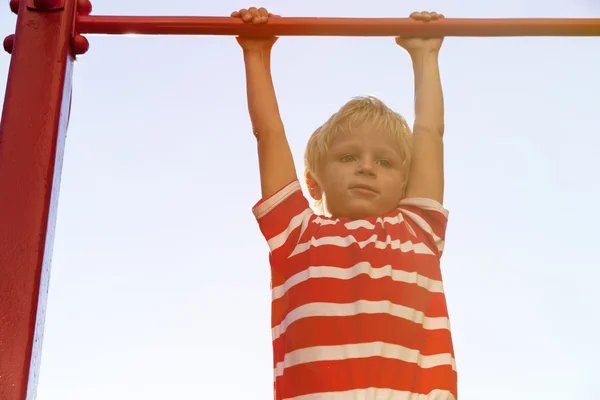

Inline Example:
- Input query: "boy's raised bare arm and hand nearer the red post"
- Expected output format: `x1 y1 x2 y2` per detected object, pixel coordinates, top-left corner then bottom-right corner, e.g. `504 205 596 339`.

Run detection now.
232 7 297 199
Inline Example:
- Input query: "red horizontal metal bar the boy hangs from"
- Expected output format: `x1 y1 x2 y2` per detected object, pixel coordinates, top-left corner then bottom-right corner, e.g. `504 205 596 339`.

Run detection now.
76 16 600 37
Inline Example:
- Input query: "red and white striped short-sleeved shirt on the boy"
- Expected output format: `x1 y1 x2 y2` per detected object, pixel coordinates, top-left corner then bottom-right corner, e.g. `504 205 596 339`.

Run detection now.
253 181 457 400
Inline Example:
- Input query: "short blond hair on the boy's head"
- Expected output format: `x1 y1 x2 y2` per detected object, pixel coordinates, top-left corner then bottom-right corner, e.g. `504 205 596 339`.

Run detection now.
304 96 412 211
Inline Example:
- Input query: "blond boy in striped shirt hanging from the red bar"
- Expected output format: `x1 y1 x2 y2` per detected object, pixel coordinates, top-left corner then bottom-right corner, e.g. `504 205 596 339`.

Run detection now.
232 8 457 400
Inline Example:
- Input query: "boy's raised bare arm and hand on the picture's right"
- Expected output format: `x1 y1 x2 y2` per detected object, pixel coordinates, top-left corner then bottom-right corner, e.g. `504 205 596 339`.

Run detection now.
396 13 444 203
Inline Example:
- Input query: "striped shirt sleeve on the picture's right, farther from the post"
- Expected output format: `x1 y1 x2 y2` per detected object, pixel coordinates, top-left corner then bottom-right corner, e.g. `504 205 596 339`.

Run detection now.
399 198 449 257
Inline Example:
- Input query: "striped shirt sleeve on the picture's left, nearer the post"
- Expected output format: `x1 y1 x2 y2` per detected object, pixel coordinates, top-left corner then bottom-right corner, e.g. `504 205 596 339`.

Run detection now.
252 180 314 260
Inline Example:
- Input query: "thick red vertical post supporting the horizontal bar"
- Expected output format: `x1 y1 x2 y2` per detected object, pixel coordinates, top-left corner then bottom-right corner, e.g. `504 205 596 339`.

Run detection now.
0 0 76 400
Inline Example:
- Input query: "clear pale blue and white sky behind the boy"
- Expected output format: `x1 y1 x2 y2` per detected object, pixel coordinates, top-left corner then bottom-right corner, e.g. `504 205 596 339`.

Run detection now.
0 0 600 400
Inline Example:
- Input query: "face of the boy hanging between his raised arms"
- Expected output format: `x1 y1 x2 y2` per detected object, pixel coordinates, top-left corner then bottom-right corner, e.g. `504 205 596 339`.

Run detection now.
312 124 404 220
